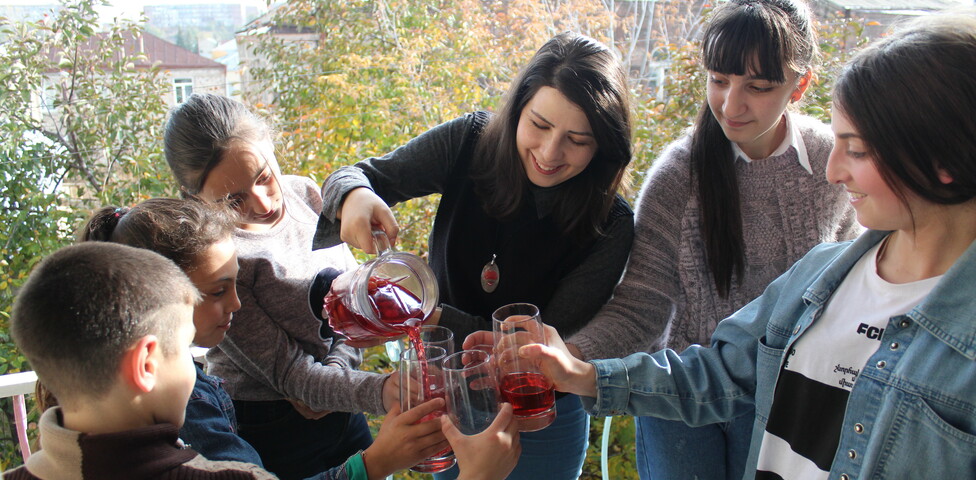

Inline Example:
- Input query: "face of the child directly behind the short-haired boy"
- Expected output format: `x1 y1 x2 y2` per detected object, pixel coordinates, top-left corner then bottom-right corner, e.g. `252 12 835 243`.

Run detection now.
188 237 241 348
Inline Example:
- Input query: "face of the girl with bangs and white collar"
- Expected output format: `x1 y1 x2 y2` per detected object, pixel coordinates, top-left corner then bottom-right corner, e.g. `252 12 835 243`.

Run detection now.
706 67 809 159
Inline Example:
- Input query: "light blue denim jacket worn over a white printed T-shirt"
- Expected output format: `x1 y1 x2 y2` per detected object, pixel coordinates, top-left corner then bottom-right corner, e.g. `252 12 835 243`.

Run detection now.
583 231 976 480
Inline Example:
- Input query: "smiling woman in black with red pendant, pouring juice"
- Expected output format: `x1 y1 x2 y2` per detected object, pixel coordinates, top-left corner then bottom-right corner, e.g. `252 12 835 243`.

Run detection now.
316 33 633 479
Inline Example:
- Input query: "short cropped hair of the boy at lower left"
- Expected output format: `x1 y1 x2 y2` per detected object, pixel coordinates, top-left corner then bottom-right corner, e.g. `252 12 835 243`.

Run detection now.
10 242 199 404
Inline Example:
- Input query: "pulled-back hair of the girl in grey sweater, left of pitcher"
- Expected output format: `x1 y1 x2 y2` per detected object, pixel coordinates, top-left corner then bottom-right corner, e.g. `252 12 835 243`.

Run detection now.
163 93 272 195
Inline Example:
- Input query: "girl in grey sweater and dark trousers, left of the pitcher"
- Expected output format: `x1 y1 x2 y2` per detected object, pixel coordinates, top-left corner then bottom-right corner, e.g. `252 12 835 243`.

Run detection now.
164 94 408 478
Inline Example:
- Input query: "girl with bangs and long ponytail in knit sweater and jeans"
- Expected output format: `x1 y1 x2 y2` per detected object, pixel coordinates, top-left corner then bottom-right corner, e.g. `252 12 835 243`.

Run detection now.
568 0 859 480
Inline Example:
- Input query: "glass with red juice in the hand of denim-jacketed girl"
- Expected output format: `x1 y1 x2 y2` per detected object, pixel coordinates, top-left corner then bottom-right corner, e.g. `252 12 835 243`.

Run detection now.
491 303 556 432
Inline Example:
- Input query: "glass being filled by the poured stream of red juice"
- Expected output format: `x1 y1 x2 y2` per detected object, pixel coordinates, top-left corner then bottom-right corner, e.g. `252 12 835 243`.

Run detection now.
399 346 457 473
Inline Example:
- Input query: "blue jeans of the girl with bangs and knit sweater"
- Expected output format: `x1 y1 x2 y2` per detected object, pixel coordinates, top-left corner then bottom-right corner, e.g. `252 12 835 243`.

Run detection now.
634 413 756 480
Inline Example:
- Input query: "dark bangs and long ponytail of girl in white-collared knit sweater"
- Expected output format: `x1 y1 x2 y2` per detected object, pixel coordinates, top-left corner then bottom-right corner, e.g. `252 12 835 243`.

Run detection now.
691 0 818 297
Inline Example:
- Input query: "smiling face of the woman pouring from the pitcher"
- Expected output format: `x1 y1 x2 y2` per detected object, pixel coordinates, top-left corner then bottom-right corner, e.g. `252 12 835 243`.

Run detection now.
515 87 597 187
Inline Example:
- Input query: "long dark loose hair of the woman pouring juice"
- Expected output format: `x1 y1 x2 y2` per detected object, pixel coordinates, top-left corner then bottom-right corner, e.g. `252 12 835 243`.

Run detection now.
471 33 631 240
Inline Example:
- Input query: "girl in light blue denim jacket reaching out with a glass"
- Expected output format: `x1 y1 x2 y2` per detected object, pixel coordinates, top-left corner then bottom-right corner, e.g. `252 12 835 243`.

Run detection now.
510 10 976 480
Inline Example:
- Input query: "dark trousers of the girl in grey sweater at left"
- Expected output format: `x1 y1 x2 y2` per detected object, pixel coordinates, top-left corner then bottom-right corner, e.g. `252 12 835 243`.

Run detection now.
234 400 373 480
